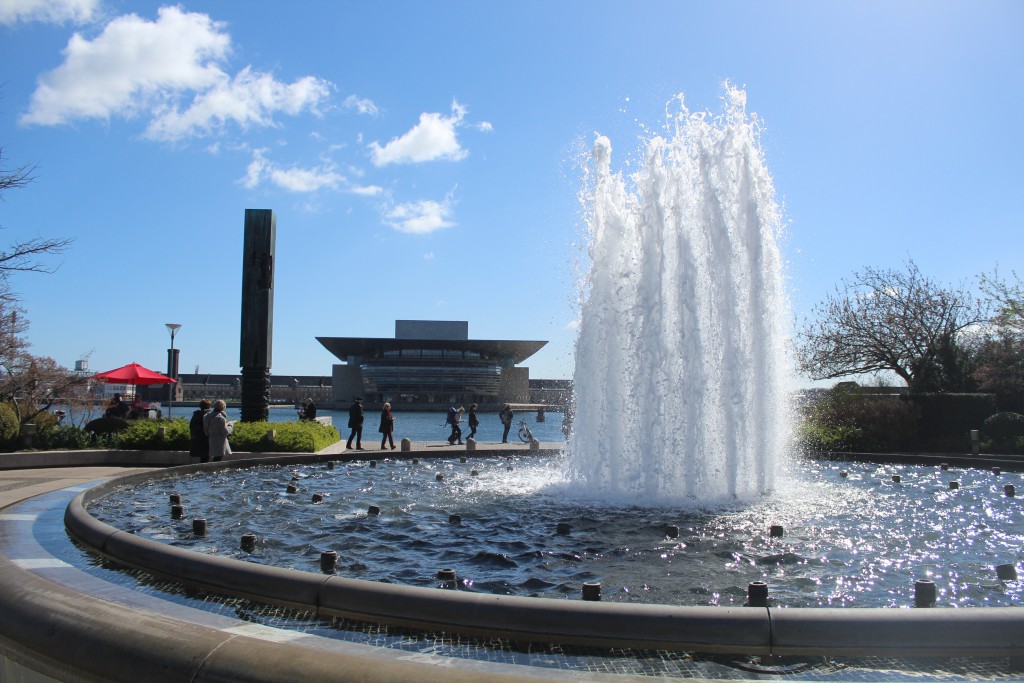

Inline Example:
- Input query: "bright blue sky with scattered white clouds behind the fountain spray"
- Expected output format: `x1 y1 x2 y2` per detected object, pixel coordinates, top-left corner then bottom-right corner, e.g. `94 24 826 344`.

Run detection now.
0 0 1024 378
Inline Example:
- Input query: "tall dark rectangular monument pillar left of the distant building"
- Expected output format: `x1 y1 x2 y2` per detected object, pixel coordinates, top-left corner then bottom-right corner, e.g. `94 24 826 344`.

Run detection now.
239 209 278 422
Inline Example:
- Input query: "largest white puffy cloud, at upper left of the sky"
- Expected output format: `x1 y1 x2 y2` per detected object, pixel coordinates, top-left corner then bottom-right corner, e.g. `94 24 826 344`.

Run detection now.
20 5 330 140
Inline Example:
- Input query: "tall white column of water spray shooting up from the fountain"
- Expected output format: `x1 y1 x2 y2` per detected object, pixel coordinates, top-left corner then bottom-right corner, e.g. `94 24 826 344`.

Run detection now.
569 86 792 503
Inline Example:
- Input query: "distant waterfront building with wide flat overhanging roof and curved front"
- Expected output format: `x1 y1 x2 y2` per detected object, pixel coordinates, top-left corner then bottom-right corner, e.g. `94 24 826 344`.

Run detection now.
316 321 548 407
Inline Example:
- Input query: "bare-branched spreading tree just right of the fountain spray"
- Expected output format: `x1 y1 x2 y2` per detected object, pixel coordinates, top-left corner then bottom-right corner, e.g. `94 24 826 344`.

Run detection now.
797 260 988 391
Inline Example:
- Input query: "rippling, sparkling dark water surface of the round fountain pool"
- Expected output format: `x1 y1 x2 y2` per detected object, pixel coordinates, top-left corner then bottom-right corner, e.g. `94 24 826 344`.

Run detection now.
90 457 1024 607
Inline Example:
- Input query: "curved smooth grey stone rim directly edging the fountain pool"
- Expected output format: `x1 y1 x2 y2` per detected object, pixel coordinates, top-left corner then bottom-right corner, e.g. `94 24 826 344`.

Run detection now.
65 456 1024 657
